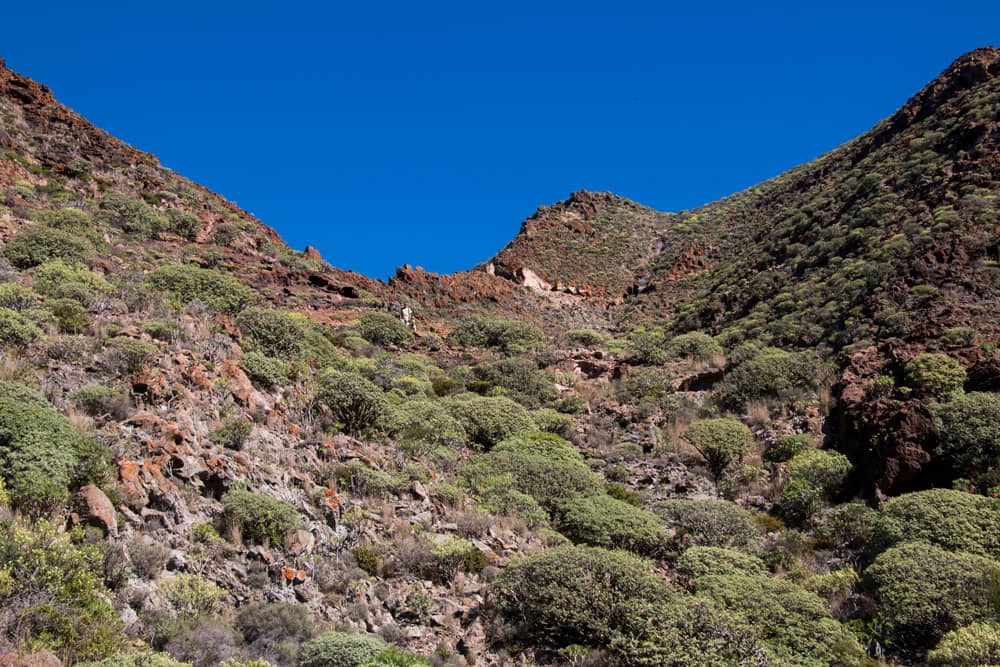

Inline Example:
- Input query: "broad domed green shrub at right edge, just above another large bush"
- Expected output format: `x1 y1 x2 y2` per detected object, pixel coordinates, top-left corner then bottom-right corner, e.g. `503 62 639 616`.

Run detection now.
870 489 1000 559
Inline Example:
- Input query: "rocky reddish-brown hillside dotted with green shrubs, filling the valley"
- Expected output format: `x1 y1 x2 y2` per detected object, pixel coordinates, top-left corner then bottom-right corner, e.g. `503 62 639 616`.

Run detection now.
0 48 1000 667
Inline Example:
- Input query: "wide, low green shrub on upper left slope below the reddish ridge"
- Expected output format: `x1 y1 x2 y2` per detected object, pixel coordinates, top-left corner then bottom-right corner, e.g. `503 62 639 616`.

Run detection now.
148 264 260 314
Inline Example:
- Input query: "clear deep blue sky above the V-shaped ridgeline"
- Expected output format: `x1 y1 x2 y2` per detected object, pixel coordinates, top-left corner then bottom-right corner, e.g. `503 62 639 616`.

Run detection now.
0 0 1000 277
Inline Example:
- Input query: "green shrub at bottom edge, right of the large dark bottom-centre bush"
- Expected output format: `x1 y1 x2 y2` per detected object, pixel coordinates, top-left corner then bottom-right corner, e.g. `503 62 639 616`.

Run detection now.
695 574 864 667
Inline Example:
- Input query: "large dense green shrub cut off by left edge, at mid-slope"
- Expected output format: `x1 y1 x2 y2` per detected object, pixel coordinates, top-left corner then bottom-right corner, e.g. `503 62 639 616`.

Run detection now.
0 382 107 510
